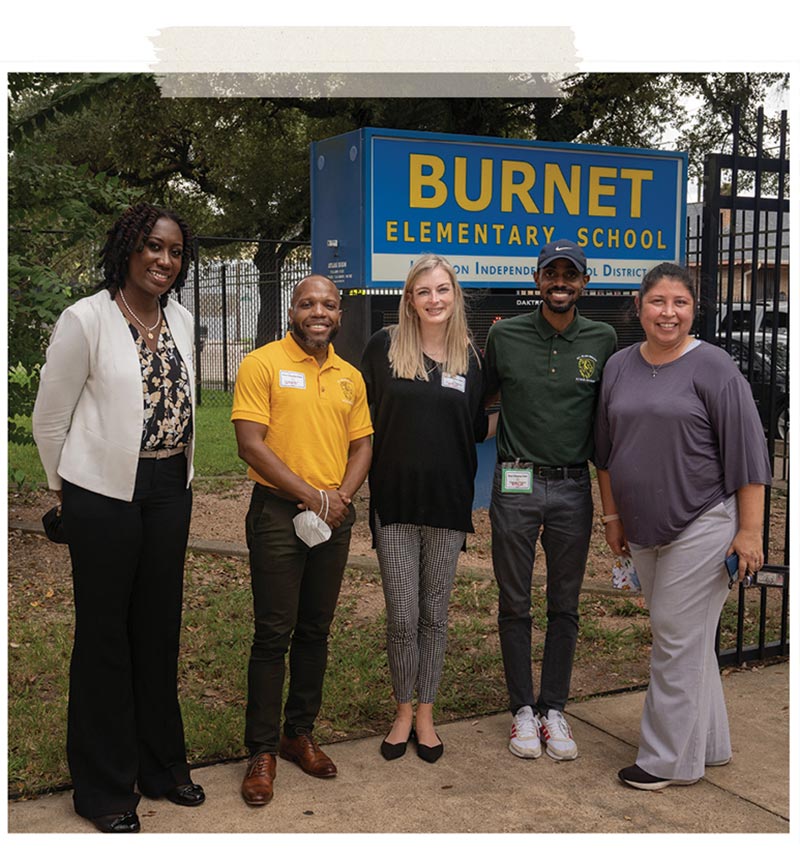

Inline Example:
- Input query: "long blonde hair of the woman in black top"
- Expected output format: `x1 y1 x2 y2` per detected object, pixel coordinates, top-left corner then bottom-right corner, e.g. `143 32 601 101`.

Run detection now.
388 253 480 381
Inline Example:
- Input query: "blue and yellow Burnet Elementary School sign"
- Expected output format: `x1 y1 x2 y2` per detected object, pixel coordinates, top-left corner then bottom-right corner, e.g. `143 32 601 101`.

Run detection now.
311 128 688 294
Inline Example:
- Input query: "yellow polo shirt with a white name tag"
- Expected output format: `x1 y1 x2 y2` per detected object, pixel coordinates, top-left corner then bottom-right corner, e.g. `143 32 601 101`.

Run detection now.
231 334 372 489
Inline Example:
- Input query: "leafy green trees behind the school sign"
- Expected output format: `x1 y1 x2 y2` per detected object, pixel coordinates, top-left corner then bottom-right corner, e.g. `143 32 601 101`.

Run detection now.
9 74 788 434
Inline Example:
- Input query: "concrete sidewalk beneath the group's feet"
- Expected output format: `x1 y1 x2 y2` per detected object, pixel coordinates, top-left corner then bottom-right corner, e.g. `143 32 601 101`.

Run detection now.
8 663 789 832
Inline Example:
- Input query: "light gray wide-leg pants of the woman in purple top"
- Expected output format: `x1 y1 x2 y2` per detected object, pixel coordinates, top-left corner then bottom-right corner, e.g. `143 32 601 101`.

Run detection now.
630 495 738 780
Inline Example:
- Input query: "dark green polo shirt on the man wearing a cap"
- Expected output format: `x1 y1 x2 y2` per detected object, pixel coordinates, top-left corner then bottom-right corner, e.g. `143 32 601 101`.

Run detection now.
486 308 617 465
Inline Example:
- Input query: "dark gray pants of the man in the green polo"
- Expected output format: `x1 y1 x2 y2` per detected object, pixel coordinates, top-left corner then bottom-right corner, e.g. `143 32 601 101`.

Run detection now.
489 465 592 712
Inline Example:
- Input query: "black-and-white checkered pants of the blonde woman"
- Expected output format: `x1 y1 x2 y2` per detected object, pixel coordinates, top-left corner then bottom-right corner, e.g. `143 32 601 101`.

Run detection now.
375 514 464 703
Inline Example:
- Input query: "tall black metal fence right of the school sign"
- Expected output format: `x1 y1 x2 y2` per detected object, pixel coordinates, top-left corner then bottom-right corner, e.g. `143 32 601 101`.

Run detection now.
690 111 790 664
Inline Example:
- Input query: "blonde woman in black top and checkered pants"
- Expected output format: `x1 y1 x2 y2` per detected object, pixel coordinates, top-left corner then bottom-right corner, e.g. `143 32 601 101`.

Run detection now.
361 254 496 763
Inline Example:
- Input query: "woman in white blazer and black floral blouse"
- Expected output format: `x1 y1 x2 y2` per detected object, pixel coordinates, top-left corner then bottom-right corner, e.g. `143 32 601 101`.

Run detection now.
33 203 205 833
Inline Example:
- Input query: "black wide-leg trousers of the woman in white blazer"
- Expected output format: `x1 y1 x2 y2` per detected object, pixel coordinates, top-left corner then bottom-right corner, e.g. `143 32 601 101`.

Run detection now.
62 455 192 818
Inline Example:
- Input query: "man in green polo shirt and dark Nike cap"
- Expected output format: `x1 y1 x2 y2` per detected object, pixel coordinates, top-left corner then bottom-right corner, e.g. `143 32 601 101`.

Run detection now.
486 240 617 760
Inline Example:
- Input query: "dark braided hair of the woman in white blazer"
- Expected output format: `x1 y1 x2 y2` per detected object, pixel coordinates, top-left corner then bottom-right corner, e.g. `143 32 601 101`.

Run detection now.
97 202 193 307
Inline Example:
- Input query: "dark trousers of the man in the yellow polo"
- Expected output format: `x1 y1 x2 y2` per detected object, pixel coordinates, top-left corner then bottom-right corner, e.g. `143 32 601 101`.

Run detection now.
245 483 355 756
